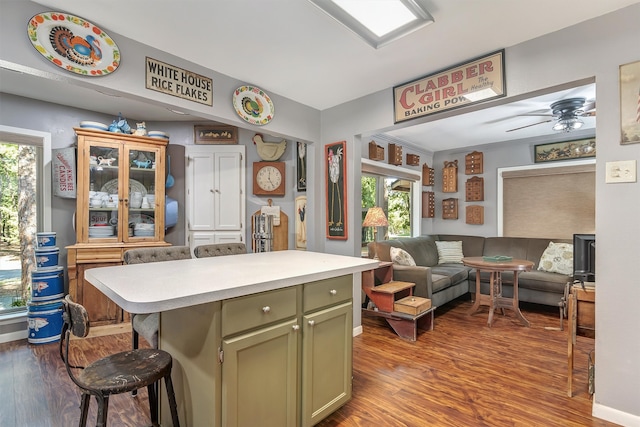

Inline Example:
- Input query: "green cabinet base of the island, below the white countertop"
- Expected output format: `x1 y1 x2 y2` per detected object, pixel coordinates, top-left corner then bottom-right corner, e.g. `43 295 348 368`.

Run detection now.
160 274 353 427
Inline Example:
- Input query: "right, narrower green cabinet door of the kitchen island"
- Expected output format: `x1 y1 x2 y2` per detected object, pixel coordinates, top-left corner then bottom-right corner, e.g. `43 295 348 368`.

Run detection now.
302 302 353 427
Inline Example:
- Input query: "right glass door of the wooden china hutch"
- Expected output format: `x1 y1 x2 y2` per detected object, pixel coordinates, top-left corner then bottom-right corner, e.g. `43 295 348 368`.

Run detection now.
123 146 164 241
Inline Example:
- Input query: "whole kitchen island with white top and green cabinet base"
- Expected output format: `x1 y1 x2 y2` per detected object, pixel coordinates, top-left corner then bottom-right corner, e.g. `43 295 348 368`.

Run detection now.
85 251 378 427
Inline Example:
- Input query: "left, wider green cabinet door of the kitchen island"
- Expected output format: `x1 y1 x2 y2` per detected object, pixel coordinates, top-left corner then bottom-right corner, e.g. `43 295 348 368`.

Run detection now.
222 319 299 427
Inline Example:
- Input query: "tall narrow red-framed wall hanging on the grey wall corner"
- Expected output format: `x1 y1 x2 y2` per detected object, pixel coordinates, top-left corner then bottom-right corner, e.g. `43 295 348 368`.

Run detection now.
324 141 348 240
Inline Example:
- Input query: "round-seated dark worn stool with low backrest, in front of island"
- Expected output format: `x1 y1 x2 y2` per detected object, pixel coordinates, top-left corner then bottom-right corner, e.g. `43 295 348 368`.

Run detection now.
60 295 180 427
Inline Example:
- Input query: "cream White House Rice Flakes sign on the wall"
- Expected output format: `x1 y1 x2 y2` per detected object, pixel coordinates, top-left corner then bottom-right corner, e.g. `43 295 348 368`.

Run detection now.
145 57 213 106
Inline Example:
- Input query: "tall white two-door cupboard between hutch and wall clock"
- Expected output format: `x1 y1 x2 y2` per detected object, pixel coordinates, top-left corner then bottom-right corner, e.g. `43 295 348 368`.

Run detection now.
185 145 246 251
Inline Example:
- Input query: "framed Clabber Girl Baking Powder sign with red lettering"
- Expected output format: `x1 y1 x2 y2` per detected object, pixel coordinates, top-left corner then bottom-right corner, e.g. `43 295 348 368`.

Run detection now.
393 50 507 123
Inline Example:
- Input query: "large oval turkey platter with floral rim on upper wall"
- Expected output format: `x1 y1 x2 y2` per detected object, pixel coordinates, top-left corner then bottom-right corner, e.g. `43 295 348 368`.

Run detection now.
27 12 120 76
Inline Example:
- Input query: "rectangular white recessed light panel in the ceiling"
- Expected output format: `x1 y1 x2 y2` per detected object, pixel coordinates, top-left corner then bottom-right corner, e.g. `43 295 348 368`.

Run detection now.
309 0 433 49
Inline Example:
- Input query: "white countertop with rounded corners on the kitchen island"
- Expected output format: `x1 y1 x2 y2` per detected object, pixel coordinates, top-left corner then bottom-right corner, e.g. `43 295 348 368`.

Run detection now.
85 250 378 313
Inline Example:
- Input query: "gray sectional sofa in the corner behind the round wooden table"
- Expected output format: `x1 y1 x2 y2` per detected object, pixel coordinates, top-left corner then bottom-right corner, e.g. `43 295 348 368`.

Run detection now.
368 235 572 307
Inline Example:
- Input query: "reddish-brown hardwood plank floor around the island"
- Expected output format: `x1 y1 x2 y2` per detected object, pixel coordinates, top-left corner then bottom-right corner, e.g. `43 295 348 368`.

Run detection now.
0 300 614 427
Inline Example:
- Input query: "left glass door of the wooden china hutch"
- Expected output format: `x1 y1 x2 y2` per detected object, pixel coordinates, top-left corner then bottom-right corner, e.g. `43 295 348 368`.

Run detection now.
86 141 122 241
